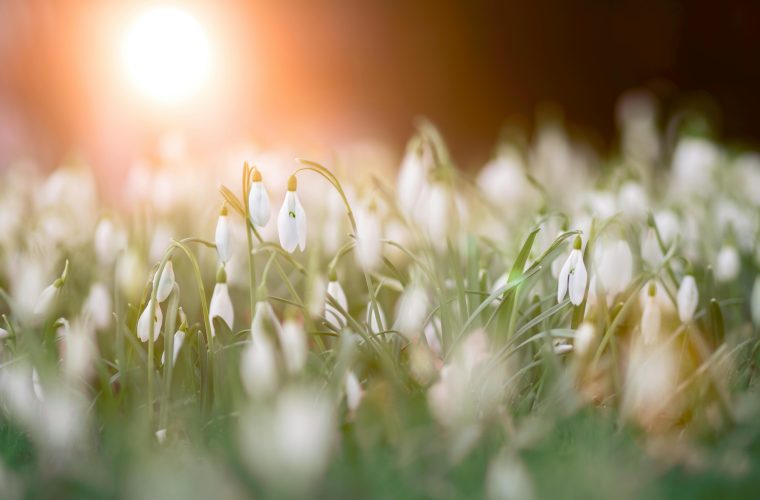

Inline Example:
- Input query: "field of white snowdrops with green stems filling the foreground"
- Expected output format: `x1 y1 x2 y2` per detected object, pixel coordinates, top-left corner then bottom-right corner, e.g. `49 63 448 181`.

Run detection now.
0 96 760 499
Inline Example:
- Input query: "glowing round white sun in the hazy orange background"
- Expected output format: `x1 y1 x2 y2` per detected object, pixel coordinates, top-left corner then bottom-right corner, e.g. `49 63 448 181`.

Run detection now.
122 6 210 103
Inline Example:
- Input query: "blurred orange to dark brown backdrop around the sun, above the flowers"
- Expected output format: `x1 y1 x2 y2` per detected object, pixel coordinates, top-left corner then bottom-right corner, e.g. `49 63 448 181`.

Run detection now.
0 0 760 179
